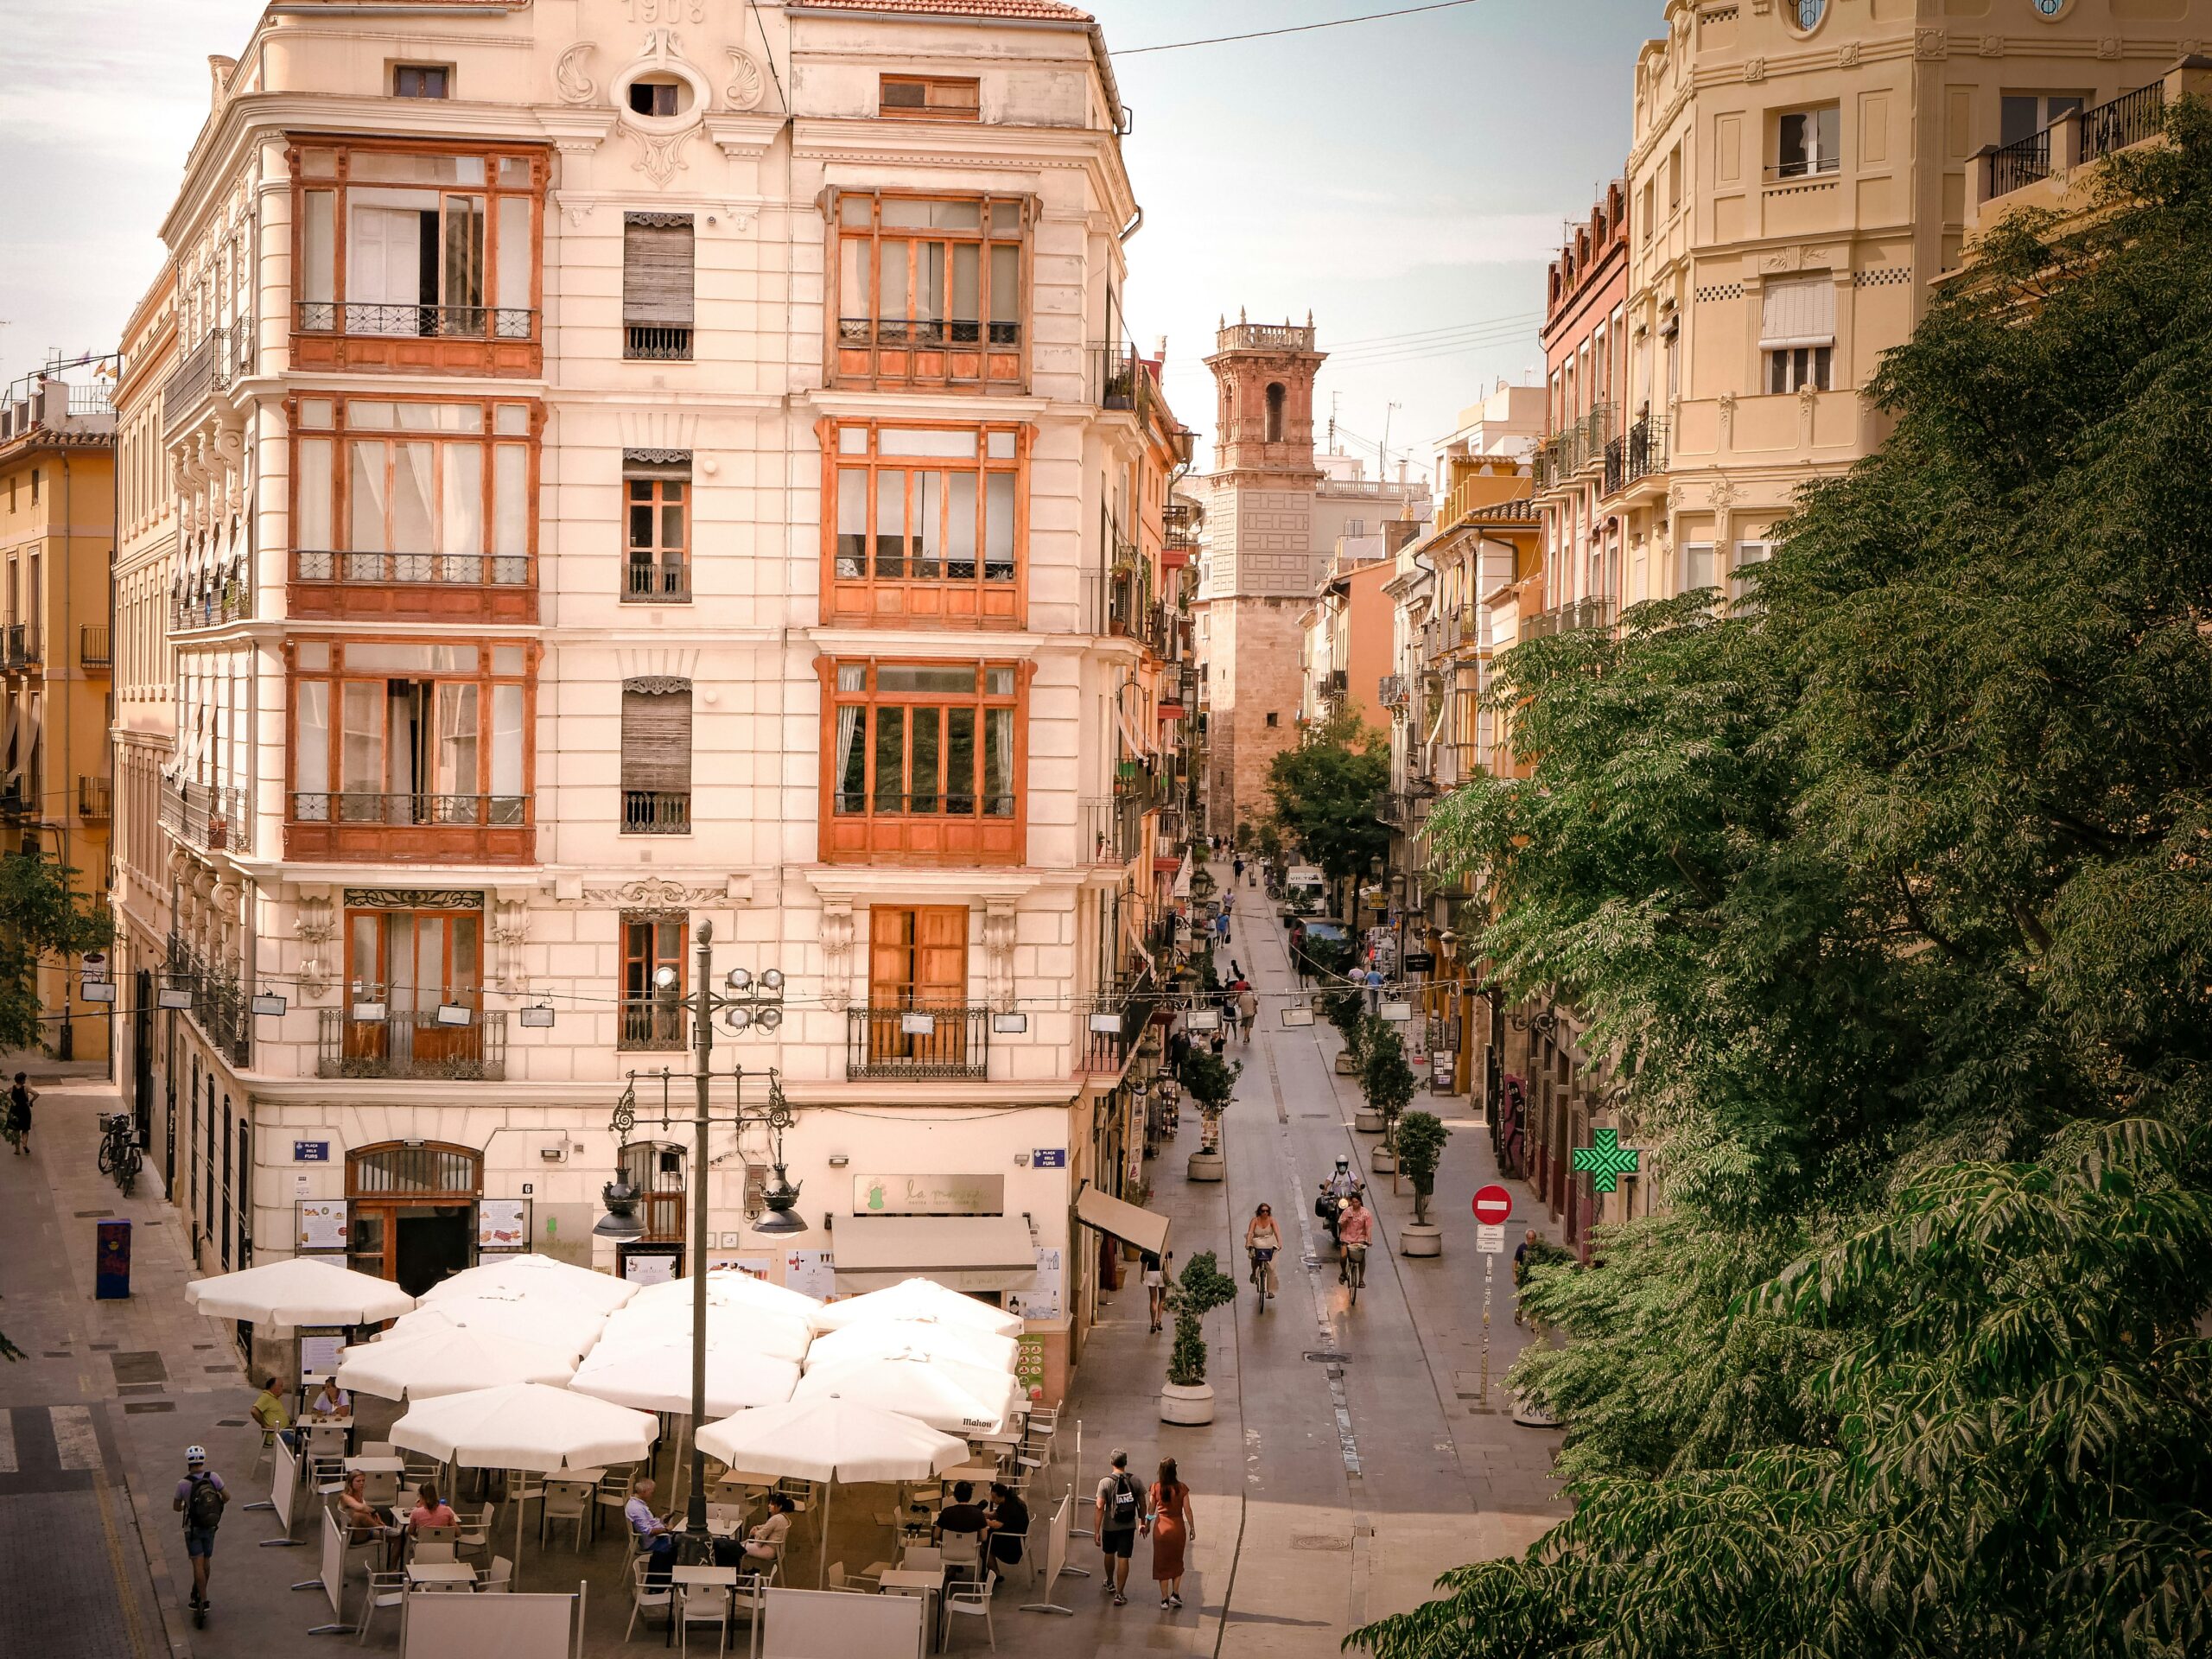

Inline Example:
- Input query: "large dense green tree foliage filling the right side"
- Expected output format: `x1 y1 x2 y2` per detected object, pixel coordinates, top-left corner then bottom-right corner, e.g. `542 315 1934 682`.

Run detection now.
1363 102 2212 1659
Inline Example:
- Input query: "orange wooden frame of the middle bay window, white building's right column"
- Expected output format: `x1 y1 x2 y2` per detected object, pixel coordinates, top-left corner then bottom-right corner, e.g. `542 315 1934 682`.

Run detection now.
817 420 1035 628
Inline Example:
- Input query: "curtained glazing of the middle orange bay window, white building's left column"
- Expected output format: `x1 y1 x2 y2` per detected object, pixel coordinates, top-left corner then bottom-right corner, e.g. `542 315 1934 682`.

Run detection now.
292 396 537 588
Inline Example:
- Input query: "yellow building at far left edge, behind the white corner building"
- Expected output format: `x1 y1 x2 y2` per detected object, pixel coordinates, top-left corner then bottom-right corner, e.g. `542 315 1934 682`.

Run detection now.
0 359 115 1059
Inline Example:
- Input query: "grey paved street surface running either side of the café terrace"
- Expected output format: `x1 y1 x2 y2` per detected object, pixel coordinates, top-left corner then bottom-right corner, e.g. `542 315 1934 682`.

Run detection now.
0 892 1561 1659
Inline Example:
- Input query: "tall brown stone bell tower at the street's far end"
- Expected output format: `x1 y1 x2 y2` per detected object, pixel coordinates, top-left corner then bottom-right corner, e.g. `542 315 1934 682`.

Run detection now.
1199 315 1336 834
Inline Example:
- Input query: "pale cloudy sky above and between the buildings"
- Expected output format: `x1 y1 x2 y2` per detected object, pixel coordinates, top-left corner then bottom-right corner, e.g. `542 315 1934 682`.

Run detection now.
0 0 1663 480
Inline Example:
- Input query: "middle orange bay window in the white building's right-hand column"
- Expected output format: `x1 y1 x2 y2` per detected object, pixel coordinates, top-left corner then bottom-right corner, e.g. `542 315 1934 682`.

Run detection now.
823 420 1027 626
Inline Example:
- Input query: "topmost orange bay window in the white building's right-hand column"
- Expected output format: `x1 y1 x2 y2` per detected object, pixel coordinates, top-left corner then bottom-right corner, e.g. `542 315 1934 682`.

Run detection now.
834 190 1027 385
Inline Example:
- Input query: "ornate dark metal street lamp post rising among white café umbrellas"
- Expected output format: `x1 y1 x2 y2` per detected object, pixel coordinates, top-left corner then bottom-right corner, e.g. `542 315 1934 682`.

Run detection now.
593 923 807 1551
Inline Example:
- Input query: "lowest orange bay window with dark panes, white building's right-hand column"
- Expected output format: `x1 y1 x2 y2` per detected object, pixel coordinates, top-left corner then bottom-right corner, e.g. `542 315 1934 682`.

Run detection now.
825 661 1022 861
